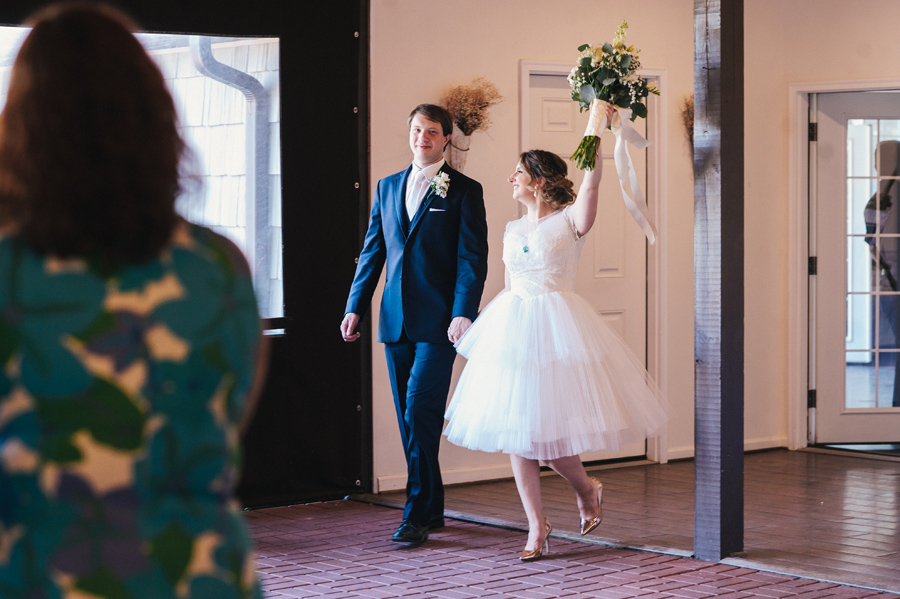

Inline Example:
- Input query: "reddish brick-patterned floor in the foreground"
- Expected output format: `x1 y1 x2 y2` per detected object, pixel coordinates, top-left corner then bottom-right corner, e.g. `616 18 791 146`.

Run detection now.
247 501 900 599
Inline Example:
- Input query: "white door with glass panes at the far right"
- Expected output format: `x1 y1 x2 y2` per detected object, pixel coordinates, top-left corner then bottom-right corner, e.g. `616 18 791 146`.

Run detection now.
811 92 900 443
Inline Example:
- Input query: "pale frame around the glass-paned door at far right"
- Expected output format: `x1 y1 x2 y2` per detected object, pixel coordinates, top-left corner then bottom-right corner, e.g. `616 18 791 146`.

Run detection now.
787 78 900 449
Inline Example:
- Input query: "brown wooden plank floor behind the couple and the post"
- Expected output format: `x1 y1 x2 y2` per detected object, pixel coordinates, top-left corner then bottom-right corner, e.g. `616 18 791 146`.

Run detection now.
354 450 900 592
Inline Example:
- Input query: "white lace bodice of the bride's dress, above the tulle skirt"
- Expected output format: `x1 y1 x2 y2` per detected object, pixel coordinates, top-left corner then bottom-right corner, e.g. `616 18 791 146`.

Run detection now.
503 207 584 297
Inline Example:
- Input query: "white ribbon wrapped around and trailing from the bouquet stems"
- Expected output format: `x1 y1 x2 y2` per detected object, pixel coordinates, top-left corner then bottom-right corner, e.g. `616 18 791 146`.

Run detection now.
584 100 657 245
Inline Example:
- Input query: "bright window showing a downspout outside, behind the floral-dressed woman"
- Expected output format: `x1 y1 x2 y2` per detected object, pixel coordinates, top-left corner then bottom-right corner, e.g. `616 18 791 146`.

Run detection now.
0 27 284 318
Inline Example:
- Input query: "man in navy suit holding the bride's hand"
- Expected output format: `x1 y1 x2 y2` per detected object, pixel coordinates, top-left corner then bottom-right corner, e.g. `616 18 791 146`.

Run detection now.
341 104 488 543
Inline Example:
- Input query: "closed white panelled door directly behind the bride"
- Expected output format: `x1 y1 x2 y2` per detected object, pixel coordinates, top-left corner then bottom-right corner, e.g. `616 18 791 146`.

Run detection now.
522 67 654 461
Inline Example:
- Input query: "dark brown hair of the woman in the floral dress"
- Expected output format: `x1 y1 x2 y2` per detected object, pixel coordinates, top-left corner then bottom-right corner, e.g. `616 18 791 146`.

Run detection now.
0 2 185 266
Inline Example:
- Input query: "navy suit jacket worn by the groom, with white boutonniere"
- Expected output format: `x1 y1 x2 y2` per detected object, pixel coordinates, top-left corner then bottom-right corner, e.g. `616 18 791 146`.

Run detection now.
345 163 488 343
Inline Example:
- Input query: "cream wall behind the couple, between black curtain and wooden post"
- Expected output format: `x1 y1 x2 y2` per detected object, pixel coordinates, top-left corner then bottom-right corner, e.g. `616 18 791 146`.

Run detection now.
370 0 694 490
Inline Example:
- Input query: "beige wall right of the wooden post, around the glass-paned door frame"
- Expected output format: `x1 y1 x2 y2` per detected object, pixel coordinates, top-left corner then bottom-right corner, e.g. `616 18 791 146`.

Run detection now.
744 0 900 445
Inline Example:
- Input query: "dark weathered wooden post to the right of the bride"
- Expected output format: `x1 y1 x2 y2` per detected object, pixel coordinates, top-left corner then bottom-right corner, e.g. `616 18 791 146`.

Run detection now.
694 0 744 561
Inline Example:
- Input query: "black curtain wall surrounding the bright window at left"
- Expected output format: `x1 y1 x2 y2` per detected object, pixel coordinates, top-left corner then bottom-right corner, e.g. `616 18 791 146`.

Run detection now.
0 0 372 507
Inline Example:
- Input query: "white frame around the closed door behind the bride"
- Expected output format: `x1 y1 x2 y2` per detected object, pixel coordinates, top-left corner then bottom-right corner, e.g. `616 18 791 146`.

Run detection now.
519 60 669 464
